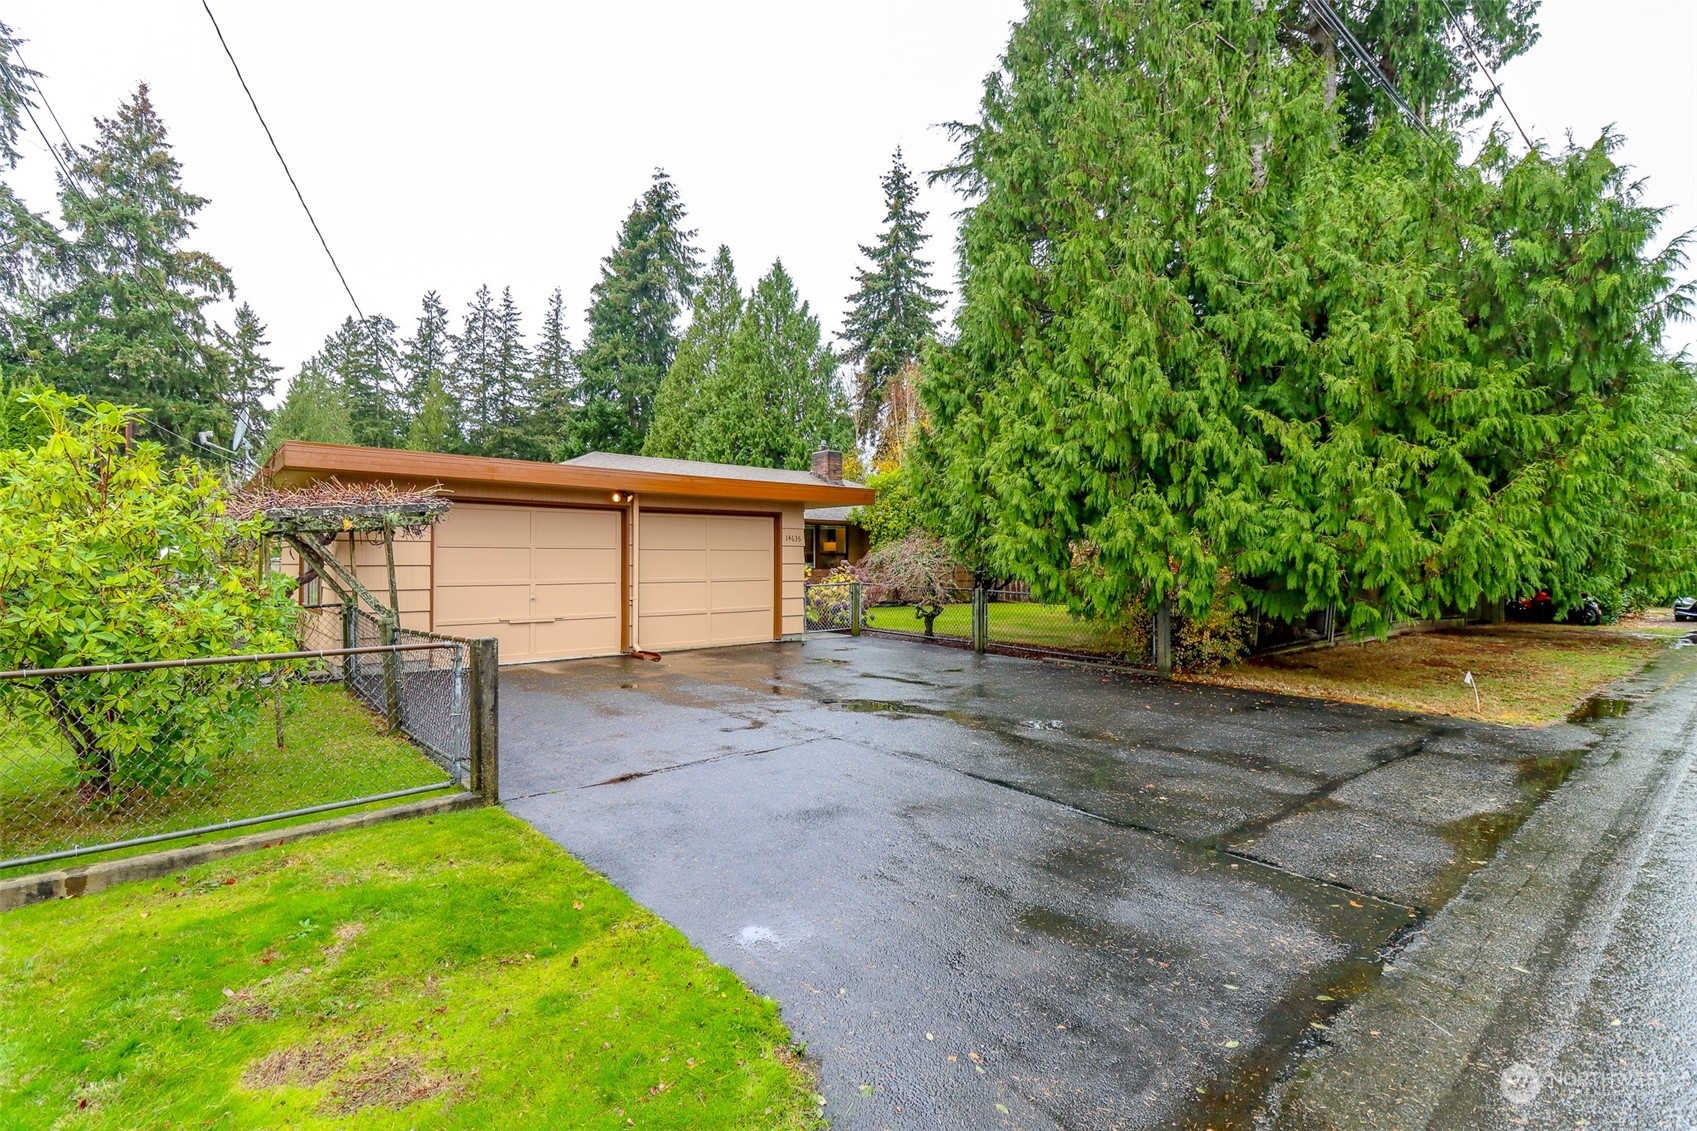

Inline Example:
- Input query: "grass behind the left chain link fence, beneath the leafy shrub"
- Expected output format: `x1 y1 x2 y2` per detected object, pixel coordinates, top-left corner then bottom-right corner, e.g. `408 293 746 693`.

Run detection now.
0 684 448 875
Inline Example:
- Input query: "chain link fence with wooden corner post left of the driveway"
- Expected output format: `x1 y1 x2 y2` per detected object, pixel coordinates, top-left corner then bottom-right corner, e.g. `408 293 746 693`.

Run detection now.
0 610 496 875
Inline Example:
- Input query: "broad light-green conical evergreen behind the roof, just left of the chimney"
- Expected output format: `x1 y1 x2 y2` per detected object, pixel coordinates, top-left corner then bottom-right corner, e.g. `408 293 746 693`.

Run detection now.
689 263 854 470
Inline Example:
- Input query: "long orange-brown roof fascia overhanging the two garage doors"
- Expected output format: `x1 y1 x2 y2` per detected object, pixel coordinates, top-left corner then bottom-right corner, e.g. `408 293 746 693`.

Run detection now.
261 440 877 506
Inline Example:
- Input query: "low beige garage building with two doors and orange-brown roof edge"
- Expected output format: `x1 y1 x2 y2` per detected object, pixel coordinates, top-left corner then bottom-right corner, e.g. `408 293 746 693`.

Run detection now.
263 440 874 662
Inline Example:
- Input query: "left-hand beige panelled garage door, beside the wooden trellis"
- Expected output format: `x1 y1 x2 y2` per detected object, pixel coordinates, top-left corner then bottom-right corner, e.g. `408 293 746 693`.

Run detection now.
433 503 623 664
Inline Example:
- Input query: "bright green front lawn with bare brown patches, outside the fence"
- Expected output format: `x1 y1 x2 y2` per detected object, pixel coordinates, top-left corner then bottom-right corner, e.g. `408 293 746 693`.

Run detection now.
0 810 820 1131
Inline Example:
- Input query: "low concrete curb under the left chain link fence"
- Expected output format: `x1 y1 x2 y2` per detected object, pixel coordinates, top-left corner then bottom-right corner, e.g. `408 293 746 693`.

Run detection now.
0 793 484 912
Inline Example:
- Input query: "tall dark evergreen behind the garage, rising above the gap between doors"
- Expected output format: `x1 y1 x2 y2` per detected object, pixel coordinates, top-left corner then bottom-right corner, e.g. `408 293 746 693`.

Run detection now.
568 170 699 455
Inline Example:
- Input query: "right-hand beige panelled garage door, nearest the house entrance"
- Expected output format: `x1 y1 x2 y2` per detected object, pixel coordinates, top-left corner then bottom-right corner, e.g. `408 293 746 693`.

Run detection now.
636 511 776 652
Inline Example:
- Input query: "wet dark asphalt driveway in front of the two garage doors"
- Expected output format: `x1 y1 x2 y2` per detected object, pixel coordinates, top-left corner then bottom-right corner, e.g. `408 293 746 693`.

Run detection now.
501 637 1590 1128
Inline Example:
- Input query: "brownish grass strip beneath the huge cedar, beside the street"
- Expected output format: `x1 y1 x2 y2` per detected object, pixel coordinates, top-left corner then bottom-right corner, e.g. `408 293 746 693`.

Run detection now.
1193 625 1668 725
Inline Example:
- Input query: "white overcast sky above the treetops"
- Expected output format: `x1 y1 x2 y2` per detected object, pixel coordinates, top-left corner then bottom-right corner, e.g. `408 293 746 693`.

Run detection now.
3 0 1697 395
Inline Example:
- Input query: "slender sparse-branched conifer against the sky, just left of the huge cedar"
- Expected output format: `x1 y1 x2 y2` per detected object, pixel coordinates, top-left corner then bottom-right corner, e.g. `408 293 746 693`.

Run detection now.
842 148 944 448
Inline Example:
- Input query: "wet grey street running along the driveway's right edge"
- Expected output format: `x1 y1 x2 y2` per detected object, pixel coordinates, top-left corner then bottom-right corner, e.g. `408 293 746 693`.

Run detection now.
1269 647 1697 1131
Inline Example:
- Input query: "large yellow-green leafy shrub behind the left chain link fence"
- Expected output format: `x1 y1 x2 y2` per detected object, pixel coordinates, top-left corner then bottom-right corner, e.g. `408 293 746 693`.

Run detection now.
0 392 295 798
